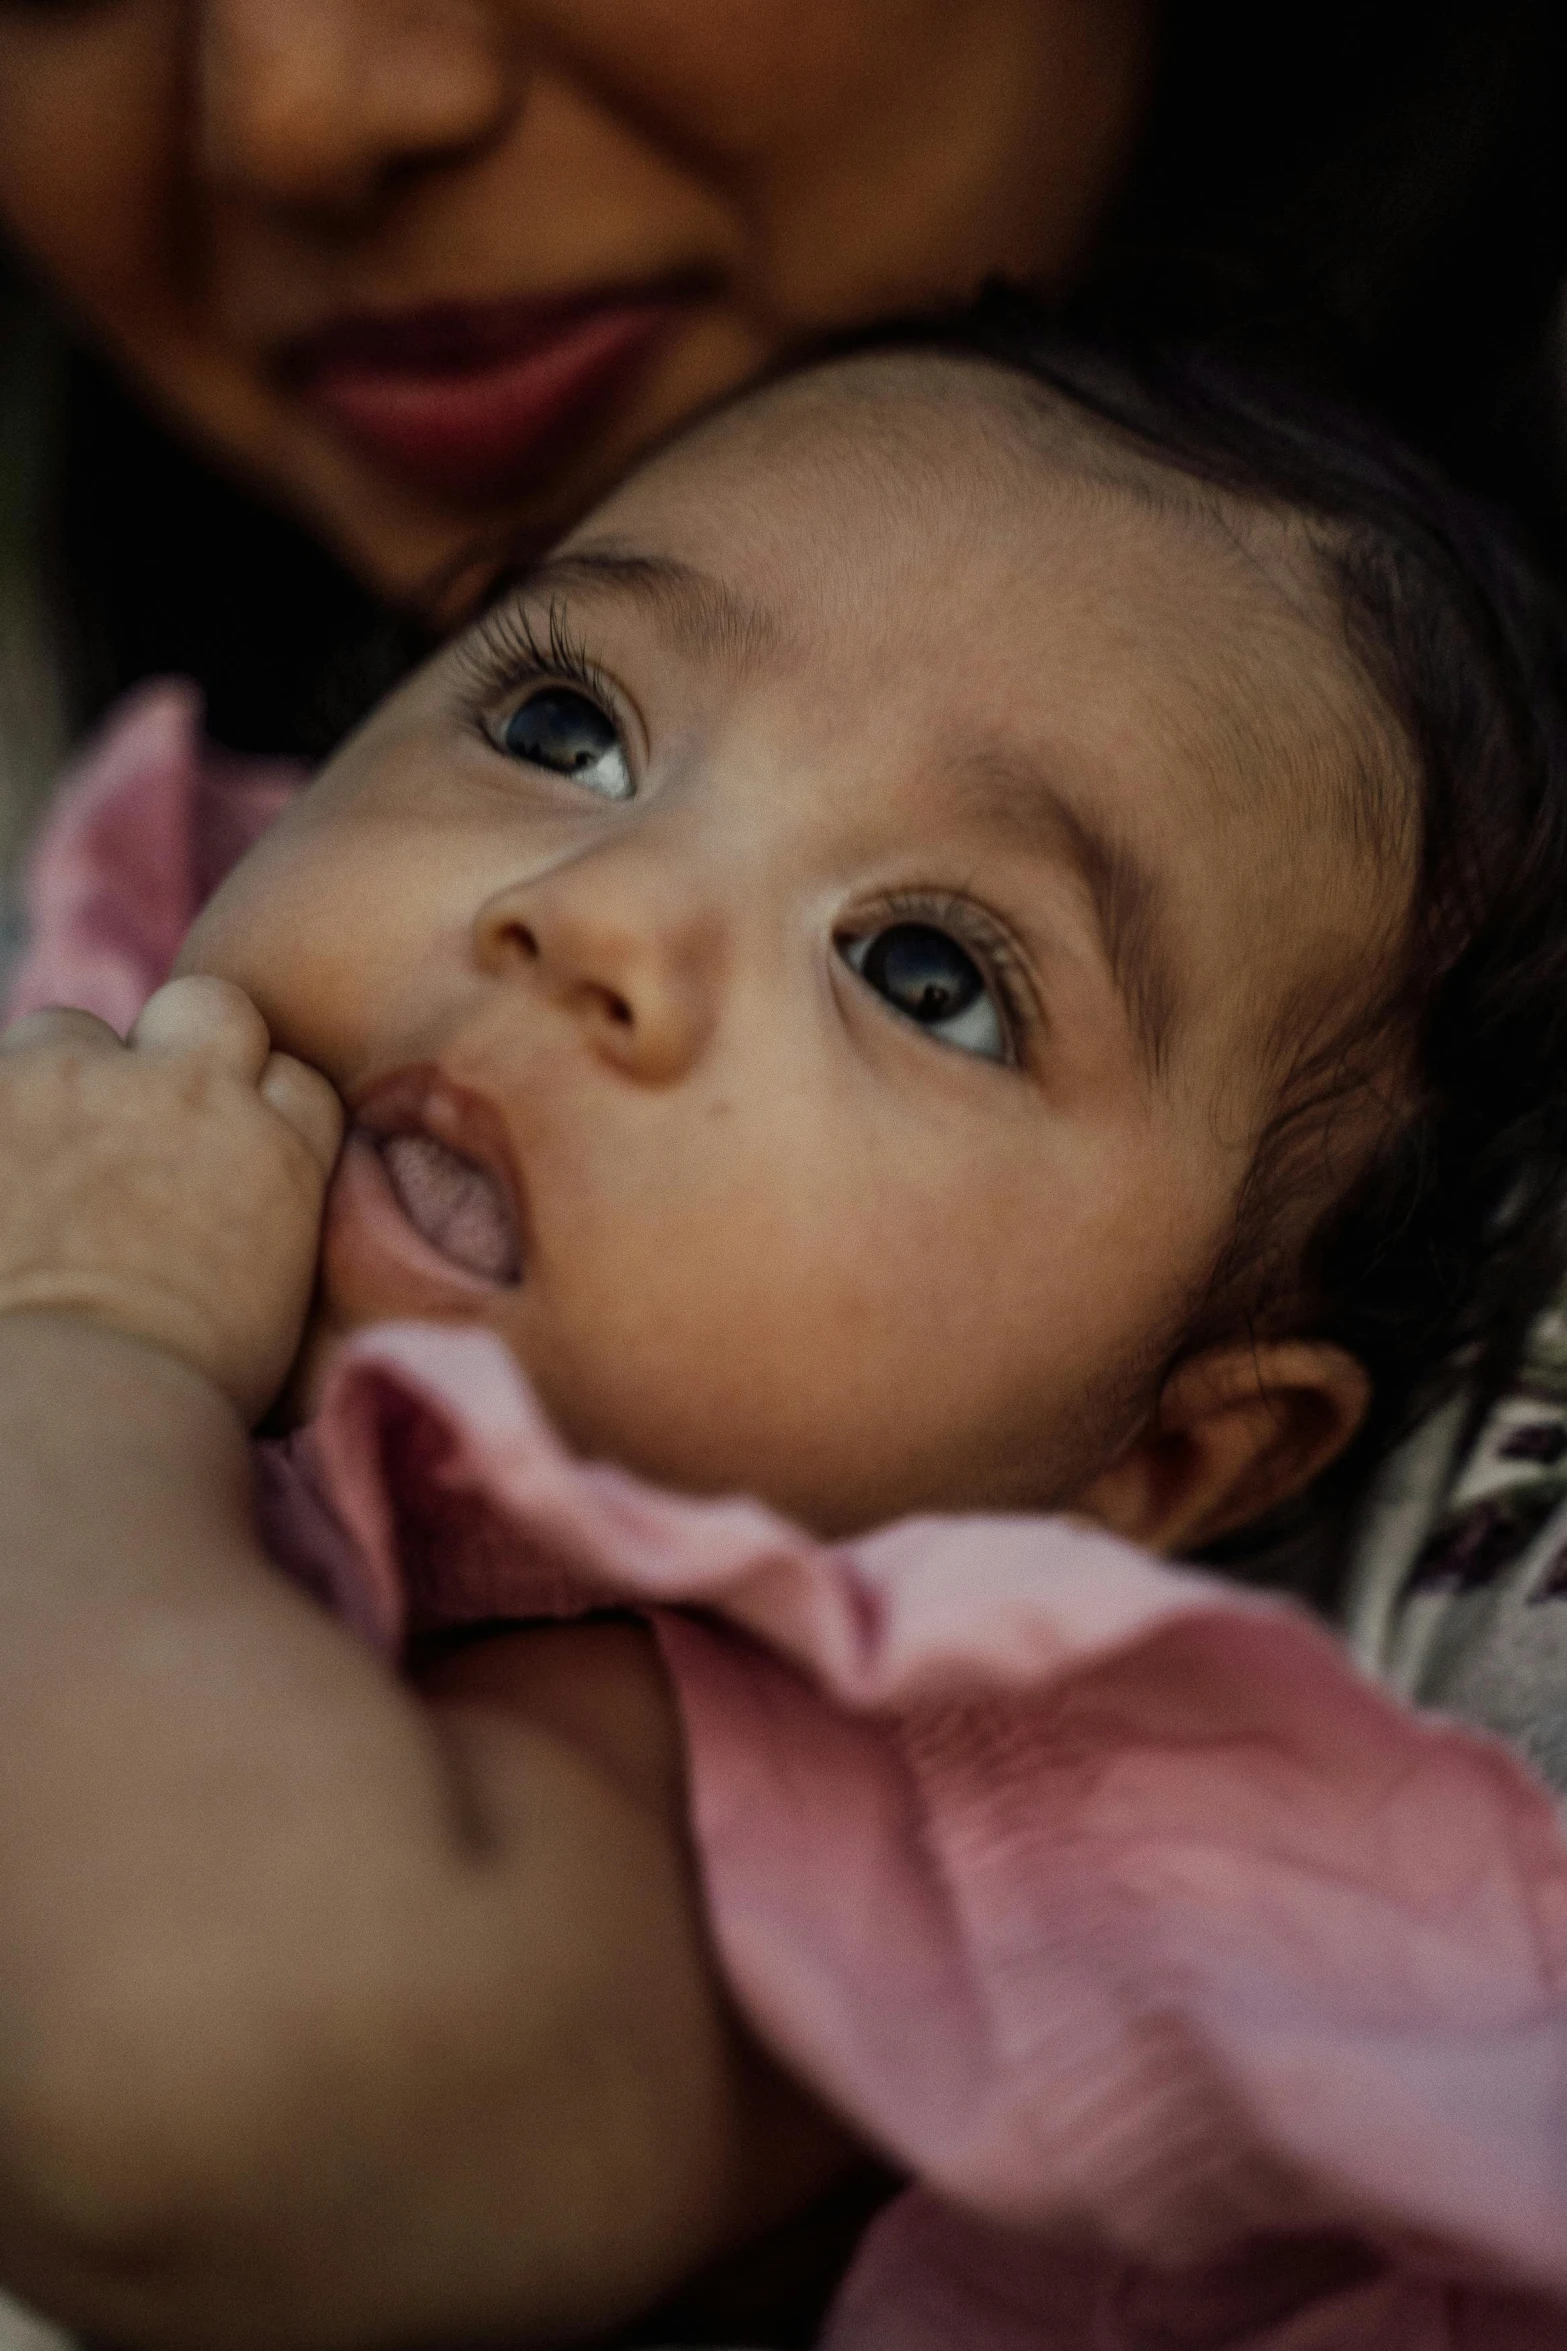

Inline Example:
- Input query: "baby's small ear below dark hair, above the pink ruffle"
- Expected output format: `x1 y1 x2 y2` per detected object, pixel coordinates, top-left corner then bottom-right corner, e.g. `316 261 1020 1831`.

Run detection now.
1069 1340 1372 1552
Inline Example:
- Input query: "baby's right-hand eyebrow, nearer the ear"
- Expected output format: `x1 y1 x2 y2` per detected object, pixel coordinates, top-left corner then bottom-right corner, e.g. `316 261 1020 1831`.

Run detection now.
961 748 1179 1077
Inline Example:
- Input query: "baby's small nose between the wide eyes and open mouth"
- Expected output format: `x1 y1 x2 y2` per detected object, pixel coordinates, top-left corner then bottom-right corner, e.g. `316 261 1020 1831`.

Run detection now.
472 858 726 1086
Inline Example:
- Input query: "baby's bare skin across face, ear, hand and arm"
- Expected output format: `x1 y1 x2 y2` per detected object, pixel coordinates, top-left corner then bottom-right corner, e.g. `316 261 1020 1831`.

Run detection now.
0 360 1410 2351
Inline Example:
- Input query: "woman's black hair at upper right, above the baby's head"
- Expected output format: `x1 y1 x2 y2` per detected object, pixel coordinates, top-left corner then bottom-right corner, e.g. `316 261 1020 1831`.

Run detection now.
1099 0 1567 552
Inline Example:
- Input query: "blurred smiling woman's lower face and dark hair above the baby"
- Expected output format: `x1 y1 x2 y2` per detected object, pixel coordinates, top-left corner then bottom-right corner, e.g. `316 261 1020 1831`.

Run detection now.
0 0 1567 771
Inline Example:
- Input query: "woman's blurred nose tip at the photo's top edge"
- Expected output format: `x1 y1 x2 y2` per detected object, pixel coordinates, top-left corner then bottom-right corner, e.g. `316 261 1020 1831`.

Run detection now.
197 0 517 214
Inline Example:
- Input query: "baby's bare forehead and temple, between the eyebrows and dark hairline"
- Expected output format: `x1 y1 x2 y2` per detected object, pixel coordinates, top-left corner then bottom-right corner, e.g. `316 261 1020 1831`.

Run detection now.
530 355 1414 1114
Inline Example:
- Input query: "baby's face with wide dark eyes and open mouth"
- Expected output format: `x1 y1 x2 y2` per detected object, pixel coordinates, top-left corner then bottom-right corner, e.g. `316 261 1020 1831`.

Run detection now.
183 360 1386 1531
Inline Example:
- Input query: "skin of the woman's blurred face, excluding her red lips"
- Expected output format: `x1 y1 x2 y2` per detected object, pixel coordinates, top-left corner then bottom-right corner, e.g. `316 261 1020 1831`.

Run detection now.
0 0 1154 614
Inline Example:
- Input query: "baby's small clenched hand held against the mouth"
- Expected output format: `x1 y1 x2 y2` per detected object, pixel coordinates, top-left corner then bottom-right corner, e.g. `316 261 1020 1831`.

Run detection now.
0 978 343 1422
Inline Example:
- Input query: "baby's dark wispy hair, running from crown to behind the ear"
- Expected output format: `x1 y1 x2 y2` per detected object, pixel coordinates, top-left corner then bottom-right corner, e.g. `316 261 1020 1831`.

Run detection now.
839 287 1567 1551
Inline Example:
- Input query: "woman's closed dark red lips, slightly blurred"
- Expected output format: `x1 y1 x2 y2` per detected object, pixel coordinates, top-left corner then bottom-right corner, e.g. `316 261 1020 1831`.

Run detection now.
284 289 686 498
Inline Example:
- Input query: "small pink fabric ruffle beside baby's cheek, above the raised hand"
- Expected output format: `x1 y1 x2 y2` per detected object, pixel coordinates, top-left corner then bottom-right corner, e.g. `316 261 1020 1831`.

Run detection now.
7 679 303 1034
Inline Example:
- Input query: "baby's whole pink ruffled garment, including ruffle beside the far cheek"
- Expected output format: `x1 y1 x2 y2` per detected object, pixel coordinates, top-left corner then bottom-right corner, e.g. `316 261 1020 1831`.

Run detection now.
19 689 1567 2351
